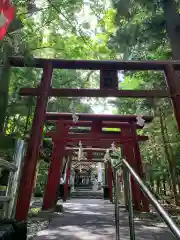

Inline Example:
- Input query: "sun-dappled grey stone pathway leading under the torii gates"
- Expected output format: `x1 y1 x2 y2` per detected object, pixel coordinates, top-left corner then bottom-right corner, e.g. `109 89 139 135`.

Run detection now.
35 199 175 240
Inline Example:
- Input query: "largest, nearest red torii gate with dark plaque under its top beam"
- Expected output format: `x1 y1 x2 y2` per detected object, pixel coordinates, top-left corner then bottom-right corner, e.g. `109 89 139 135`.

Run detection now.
12 57 180 220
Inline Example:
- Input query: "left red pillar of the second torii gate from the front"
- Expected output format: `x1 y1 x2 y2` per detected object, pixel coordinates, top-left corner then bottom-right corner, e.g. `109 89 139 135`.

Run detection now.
43 121 68 210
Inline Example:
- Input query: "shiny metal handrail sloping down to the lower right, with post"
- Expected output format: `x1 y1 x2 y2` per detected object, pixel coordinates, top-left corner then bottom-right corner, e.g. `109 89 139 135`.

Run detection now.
115 159 180 240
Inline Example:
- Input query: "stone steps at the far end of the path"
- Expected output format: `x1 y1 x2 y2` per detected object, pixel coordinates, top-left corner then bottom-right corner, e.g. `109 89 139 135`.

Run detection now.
71 187 103 199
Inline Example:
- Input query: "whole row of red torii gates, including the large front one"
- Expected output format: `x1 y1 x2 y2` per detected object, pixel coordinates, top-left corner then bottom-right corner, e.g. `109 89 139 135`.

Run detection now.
9 58 180 221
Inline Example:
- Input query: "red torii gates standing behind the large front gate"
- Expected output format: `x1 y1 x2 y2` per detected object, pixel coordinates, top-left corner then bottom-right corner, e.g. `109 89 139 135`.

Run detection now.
43 113 152 211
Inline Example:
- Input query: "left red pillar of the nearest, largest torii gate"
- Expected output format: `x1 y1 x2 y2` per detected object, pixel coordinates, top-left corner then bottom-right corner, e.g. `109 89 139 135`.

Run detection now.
15 60 53 221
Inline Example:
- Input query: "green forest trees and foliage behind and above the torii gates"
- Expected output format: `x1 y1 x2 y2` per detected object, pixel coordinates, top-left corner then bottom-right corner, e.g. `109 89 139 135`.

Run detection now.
0 0 180 205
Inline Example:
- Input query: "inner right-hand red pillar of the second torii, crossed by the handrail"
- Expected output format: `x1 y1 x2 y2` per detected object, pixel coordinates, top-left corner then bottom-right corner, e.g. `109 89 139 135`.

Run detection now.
122 128 141 211
